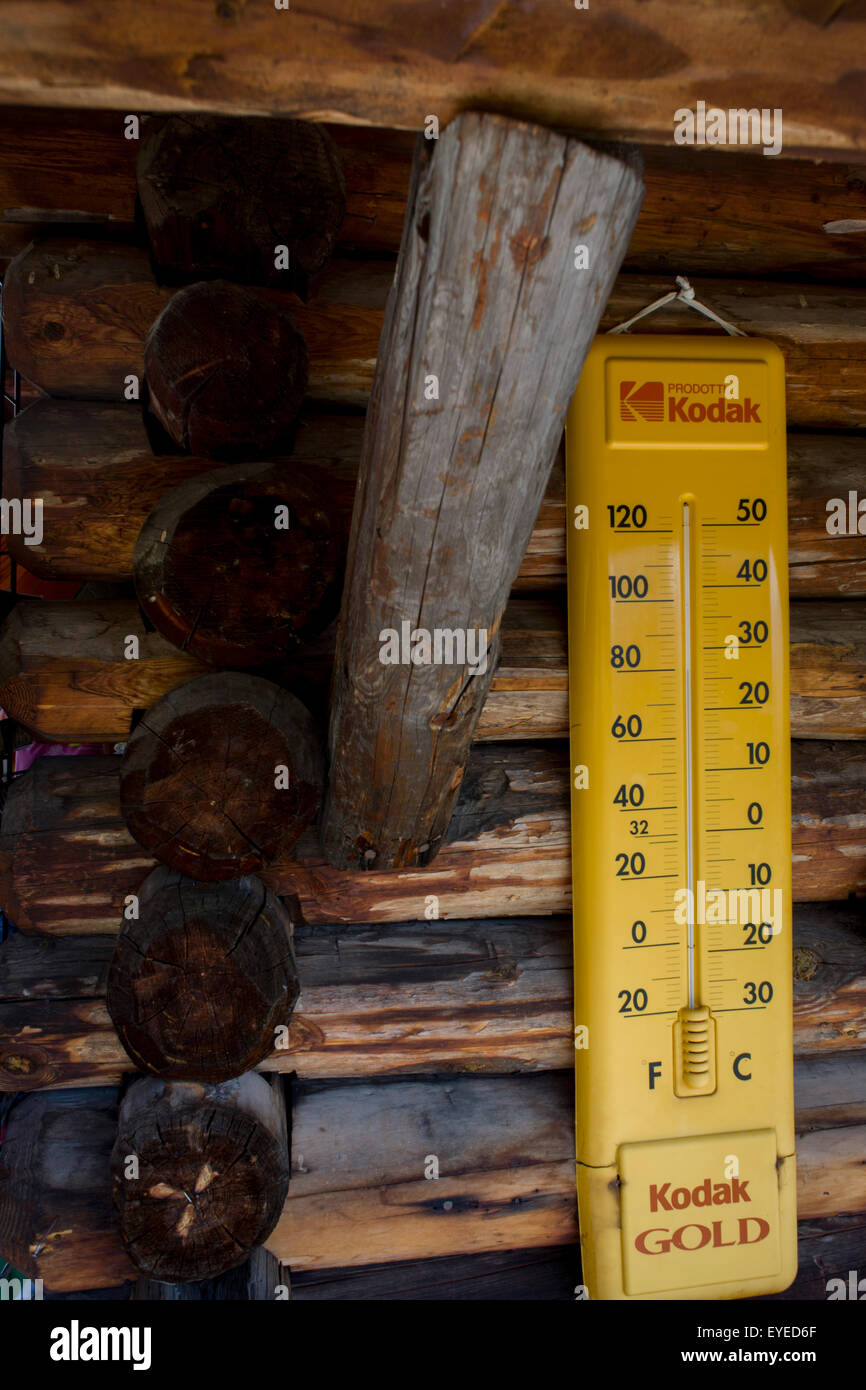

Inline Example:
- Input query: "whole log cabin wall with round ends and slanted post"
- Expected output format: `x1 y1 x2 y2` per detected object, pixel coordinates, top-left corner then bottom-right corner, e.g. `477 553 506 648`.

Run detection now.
0 4 866 1300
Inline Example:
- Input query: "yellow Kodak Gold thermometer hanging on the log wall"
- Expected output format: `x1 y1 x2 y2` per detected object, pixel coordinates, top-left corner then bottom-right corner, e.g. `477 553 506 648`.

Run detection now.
566 336 796 1298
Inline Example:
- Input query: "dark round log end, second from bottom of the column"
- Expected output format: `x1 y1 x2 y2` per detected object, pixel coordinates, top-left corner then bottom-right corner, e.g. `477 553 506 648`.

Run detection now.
107 867 299 1081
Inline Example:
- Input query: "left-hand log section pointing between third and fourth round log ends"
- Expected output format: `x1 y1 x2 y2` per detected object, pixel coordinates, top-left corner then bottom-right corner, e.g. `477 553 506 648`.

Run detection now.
0 599 207 744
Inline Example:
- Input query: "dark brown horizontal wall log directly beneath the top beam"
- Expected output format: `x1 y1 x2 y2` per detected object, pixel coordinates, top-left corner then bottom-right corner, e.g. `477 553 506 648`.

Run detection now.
6 107 866 282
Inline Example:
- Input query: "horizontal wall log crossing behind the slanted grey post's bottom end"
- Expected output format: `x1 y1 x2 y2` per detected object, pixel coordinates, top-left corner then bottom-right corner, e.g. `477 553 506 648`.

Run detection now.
0 739 866 935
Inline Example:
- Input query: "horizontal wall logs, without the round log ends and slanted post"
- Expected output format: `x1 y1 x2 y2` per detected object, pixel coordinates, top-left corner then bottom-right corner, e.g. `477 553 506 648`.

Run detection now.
0 108 866 1300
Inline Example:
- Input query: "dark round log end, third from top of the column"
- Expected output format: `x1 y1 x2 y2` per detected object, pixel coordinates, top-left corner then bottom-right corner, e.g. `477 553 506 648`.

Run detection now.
133 461 343 666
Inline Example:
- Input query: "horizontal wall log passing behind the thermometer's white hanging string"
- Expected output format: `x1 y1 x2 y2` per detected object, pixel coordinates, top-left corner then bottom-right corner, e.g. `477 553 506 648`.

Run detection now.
4 232 866 430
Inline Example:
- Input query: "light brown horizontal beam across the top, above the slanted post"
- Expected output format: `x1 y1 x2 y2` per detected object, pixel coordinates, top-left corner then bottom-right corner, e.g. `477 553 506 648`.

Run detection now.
0 0 865 156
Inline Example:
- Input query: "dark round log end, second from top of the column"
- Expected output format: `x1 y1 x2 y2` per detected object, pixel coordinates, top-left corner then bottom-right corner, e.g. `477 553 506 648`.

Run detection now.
145 279 307 459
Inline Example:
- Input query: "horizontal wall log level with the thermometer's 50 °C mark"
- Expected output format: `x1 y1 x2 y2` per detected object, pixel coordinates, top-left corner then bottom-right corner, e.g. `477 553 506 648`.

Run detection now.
3 399 866 599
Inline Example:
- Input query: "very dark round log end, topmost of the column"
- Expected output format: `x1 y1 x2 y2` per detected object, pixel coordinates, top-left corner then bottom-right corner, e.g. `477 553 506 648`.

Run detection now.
138 115 346 292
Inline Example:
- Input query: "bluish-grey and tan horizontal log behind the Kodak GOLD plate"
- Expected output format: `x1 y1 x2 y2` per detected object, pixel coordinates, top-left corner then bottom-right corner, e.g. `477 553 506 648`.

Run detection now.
0 1054 866 1291
